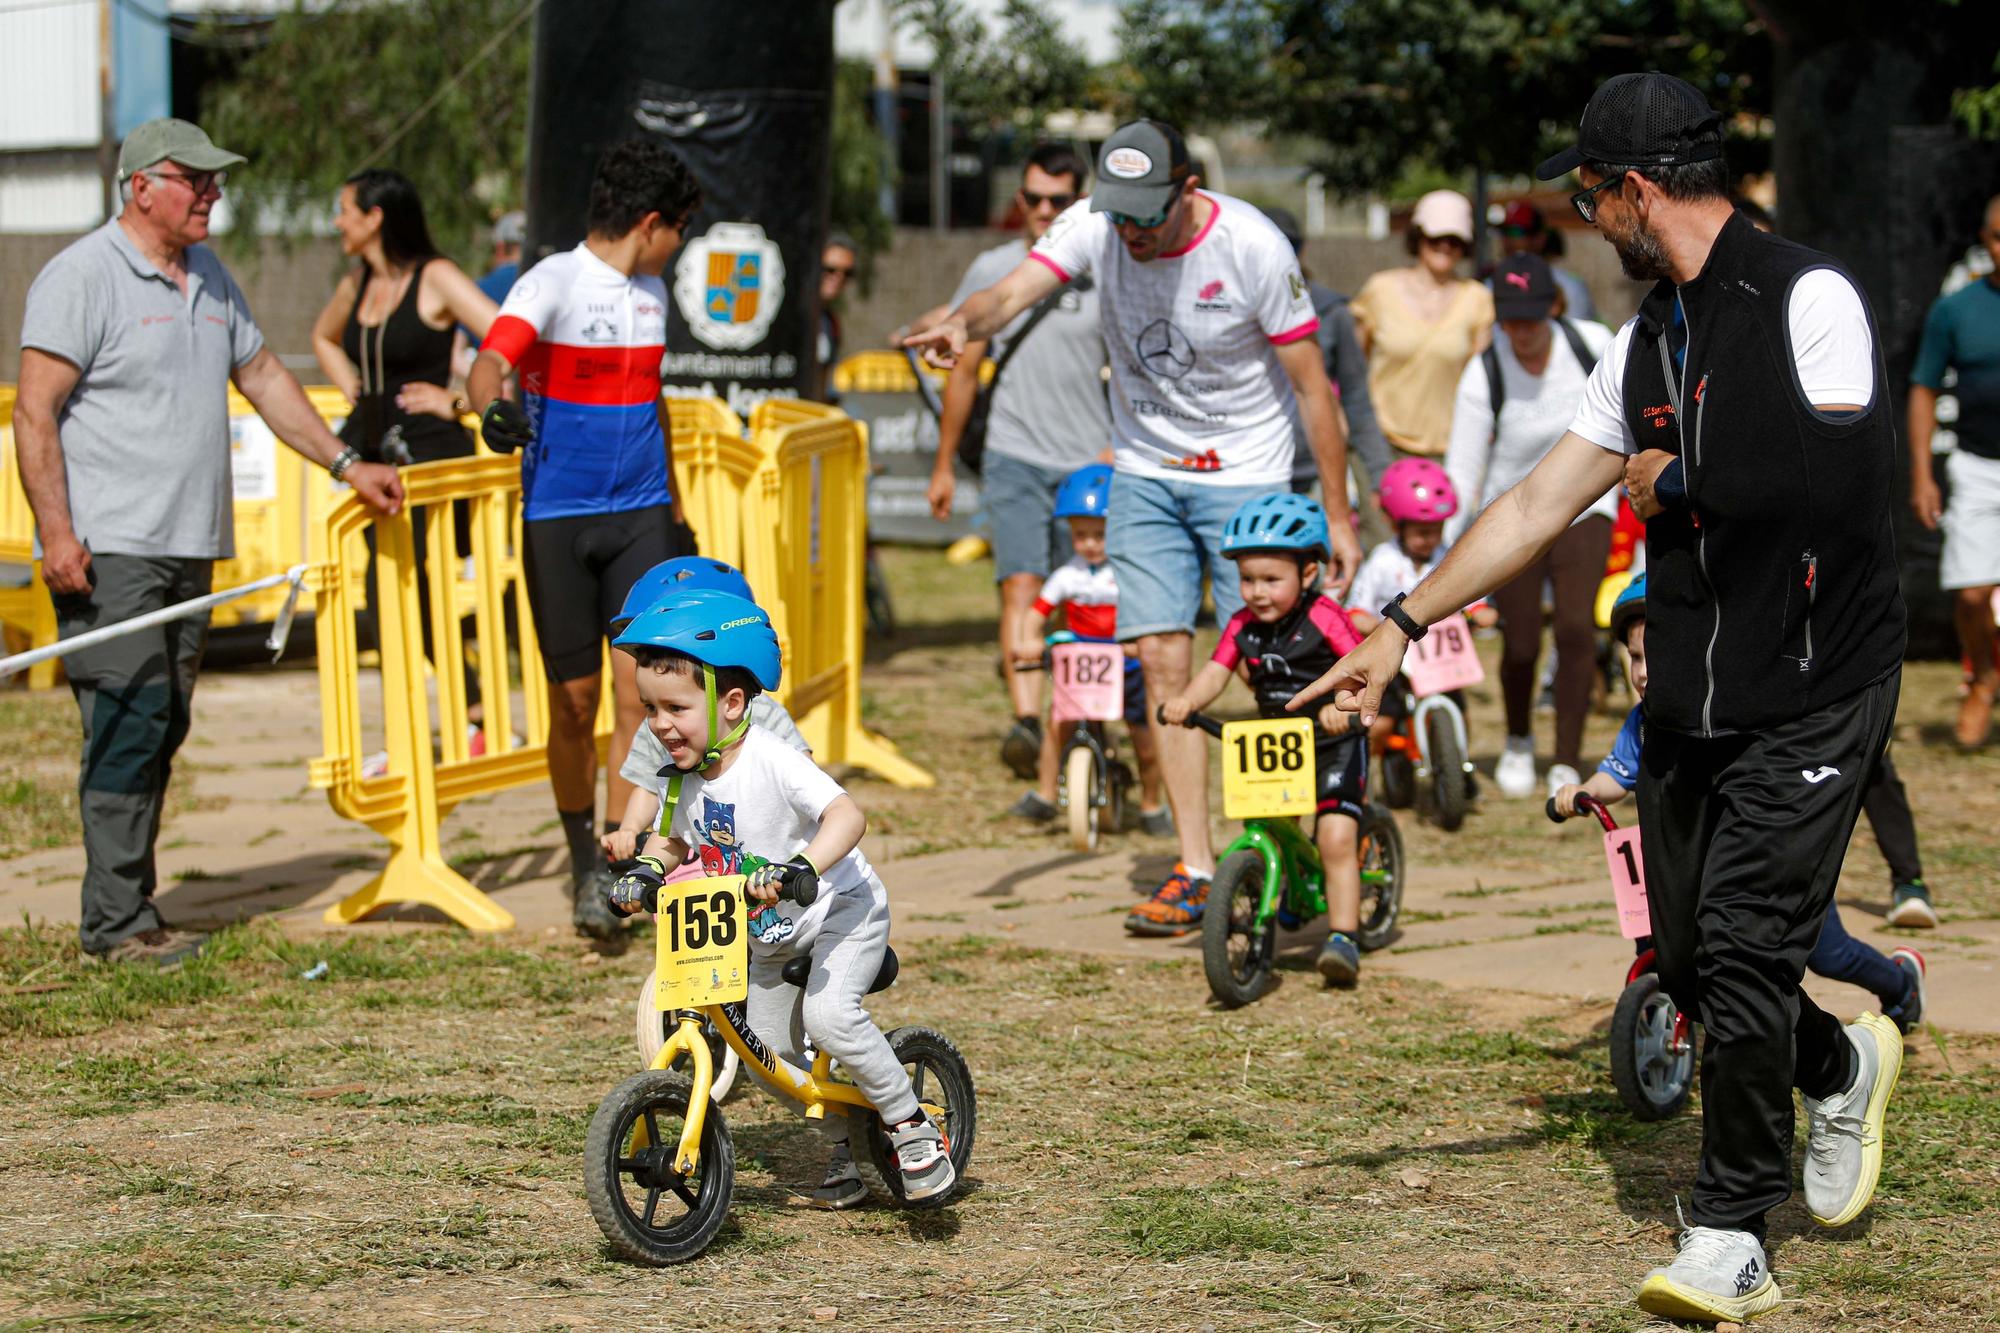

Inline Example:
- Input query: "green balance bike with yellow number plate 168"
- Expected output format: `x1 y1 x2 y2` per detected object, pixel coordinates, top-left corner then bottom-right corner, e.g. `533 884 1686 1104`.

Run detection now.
1160 713 1404 1009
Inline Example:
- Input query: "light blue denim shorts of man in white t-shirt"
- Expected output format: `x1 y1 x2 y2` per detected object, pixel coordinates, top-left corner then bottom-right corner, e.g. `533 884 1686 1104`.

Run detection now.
1104 472 1284 642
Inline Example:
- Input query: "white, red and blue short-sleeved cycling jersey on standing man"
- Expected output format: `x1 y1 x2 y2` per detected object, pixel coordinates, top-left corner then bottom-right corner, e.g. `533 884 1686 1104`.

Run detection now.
482 244 670 520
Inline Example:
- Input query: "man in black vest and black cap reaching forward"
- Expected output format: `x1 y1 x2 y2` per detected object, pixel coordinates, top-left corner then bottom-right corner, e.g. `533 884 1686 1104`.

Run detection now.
1292 74 1904 1321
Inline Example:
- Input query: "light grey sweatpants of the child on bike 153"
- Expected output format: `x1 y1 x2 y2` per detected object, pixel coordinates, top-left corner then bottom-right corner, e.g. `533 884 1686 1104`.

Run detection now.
744 887 918 1143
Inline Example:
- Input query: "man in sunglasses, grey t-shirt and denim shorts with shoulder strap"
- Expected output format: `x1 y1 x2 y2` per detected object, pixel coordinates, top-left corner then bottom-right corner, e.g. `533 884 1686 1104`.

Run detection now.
930 144 1112 788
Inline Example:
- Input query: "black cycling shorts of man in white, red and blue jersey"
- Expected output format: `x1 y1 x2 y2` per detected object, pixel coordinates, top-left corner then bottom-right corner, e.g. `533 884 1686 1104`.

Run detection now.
520 504 690 683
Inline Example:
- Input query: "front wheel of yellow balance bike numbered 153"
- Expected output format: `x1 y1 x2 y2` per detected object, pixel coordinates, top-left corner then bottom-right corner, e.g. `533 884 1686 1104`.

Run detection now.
584 1069 736 1265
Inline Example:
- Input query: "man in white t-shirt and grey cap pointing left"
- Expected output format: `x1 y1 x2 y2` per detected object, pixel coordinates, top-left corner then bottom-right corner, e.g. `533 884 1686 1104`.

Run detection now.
904 120 1360 935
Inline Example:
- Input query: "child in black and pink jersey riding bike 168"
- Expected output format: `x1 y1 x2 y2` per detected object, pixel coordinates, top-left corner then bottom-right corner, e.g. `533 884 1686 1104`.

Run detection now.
1160 494 1368 987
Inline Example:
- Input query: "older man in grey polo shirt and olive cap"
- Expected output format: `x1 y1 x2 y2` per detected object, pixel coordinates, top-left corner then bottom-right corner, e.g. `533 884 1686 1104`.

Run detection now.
14 120 402 967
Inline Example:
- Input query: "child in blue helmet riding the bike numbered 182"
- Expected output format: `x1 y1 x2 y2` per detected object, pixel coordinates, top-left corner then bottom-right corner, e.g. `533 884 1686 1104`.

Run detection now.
1008 462 1174 837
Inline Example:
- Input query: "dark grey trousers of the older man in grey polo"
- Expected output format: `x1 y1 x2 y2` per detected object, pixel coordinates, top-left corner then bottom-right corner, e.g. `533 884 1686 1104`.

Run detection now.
54 552 214 955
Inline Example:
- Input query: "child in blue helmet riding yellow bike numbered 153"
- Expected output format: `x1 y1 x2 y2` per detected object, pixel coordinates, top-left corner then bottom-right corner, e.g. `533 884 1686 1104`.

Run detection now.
612 592 954 1209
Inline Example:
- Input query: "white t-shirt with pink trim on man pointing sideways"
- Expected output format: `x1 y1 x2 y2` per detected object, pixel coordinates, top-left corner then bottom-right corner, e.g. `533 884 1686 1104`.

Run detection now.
1030 190 1320 486
